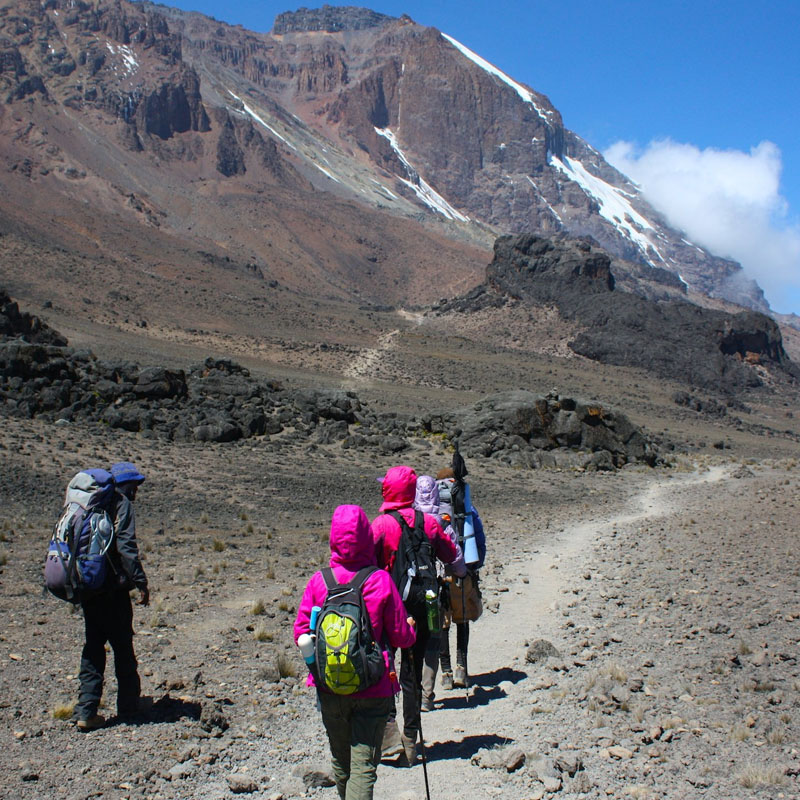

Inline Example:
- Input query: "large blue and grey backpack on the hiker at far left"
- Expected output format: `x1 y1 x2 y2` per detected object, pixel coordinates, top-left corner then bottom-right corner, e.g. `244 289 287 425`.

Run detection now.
44 469 115 603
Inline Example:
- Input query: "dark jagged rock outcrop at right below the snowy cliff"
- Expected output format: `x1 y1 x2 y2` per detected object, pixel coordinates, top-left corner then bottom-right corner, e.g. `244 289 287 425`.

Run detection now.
437 234 800 393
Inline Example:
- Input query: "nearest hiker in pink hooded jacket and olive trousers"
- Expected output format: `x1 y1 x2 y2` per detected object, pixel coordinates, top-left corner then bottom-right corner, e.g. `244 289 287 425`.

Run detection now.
294 505 415 800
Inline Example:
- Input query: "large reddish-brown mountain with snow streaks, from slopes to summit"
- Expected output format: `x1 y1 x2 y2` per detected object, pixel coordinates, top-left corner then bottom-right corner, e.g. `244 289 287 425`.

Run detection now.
0 0 766 320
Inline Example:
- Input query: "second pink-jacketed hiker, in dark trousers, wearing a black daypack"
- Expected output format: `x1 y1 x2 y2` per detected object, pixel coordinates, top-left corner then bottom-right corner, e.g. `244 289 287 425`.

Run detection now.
371 465 464 765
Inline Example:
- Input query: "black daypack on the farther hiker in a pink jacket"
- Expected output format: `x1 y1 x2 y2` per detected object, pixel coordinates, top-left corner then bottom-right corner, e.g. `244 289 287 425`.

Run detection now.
385 511 439 620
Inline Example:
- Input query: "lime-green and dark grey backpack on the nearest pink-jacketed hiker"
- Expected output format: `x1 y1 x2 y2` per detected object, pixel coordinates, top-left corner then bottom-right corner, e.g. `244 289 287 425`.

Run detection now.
314 566 386 694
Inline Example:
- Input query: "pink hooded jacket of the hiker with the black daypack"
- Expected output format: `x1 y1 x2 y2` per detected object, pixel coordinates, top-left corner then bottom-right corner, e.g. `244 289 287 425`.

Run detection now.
371 466 465 577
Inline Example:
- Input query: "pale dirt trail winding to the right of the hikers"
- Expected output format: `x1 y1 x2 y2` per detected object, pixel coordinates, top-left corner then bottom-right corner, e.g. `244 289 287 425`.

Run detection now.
376 467 725 800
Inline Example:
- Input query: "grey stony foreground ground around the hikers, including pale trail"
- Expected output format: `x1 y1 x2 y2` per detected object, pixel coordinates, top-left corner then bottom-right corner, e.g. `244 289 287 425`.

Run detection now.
0 410 800 800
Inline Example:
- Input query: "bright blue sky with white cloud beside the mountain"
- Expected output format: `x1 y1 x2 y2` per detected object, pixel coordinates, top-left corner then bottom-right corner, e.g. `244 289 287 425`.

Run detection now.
162 0 800 314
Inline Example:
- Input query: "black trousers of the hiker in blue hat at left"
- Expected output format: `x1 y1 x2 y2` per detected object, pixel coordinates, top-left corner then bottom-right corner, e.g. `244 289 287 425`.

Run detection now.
75 589 141 719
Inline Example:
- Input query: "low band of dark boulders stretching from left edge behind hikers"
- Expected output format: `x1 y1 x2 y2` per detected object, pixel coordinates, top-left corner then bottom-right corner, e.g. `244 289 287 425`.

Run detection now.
0 292 658 469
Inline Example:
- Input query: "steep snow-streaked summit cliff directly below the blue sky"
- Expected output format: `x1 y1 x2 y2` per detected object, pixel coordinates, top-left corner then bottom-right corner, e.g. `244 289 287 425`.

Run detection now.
181 7 766 310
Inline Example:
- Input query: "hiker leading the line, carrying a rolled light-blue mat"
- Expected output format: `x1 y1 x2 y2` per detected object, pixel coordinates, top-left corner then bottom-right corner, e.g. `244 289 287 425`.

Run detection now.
436 467 486 689
